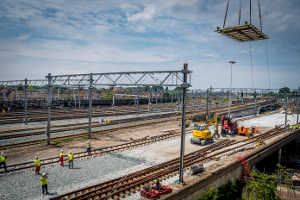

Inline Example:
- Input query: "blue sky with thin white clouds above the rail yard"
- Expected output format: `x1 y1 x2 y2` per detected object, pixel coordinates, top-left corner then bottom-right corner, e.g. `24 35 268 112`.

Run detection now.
0 0 300 89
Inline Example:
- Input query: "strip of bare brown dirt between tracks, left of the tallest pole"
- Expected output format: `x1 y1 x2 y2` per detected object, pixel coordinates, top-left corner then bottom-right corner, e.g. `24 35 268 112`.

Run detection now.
3 121 178 164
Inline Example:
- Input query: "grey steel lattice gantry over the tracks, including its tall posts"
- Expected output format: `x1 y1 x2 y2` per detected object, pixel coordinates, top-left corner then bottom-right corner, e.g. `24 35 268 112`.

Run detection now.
0 63 192 182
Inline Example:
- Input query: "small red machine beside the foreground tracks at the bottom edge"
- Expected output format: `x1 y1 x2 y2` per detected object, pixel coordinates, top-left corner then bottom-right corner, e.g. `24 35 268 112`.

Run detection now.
140 182 172 200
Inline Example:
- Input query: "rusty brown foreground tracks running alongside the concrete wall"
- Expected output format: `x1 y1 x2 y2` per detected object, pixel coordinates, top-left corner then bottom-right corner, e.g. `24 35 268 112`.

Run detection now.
50 125 292 200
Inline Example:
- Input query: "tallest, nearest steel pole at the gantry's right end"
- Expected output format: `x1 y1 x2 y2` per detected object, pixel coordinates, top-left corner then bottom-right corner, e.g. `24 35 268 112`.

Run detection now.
178 63 189 184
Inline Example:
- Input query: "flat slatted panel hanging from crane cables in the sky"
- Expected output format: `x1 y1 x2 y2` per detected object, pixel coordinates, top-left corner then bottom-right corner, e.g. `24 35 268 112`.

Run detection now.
215 23 269 42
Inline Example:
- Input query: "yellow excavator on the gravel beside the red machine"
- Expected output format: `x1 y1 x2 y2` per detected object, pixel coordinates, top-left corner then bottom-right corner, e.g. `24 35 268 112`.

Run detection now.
191 115 220 145
